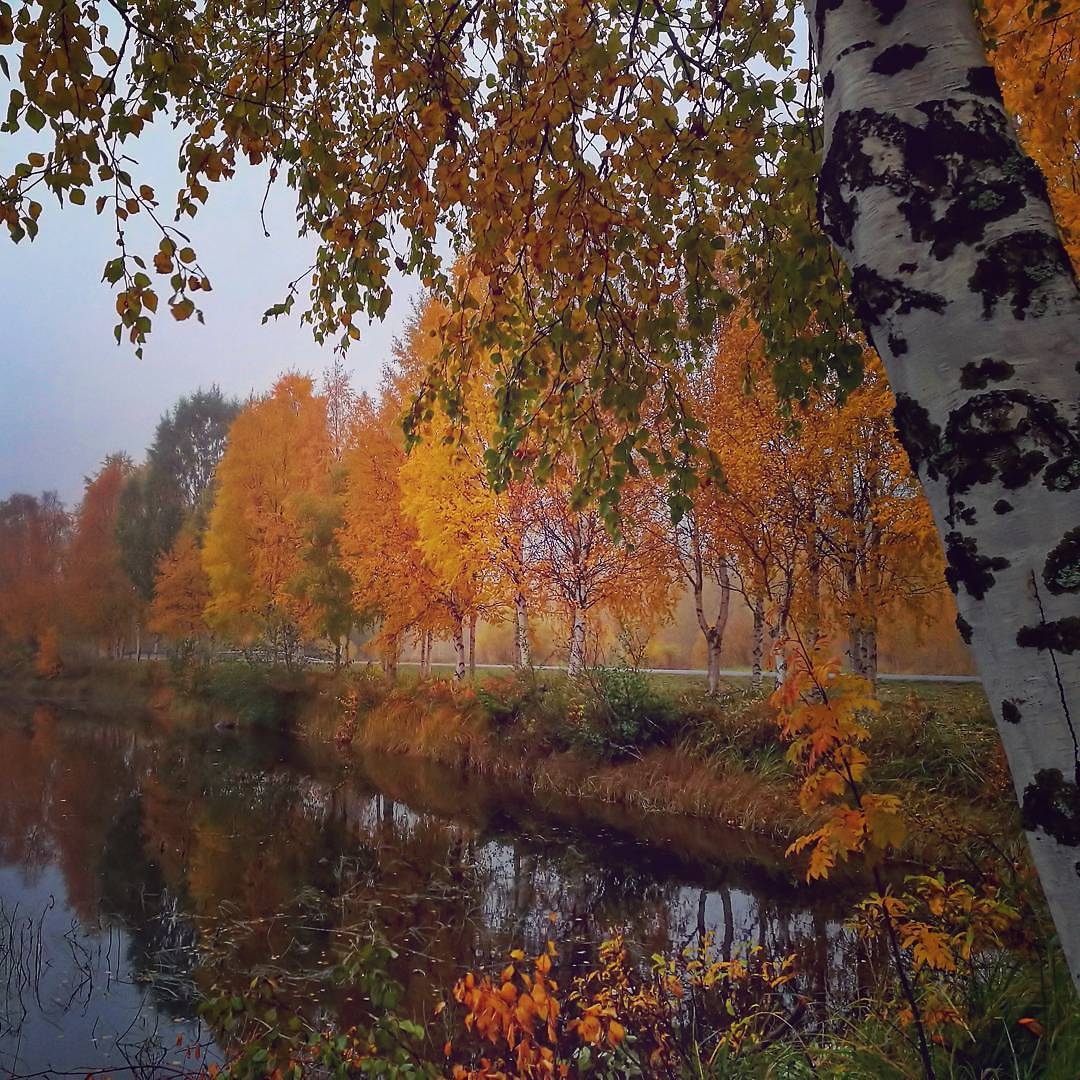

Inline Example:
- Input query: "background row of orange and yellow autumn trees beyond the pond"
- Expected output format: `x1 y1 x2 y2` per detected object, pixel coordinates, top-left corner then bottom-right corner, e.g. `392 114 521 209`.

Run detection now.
0 299 971 686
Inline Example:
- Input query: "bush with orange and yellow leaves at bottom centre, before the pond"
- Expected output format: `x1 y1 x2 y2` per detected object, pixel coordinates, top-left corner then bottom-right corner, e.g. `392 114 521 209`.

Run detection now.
445 935 796 1080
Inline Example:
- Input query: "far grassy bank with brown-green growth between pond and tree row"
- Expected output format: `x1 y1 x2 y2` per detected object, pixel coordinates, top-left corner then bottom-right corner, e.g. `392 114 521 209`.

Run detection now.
0 661 1018 861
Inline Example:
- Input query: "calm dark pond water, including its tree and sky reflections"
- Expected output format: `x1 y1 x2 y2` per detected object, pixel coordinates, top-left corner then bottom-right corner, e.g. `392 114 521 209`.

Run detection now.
0 707 866 1076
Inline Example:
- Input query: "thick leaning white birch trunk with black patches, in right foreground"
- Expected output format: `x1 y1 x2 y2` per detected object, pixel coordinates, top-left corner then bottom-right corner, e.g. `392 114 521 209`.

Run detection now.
807 0 1080 987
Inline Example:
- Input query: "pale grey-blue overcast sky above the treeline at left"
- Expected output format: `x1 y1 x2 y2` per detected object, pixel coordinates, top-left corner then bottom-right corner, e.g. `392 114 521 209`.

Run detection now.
0 138 418 503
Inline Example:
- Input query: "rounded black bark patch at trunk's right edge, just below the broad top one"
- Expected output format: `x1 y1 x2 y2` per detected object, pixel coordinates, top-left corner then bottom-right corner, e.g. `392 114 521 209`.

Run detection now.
968 229 1072 319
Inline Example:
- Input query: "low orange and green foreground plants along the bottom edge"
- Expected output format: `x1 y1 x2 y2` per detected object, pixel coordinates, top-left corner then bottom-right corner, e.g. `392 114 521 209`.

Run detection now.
204 937 1080 1080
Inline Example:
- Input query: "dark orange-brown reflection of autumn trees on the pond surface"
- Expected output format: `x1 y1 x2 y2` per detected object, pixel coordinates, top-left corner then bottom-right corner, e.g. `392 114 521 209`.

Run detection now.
0 714 865 1041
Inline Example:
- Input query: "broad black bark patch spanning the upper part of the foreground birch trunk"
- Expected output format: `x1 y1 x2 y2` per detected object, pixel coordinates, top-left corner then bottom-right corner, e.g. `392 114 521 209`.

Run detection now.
819 98 1059 259
